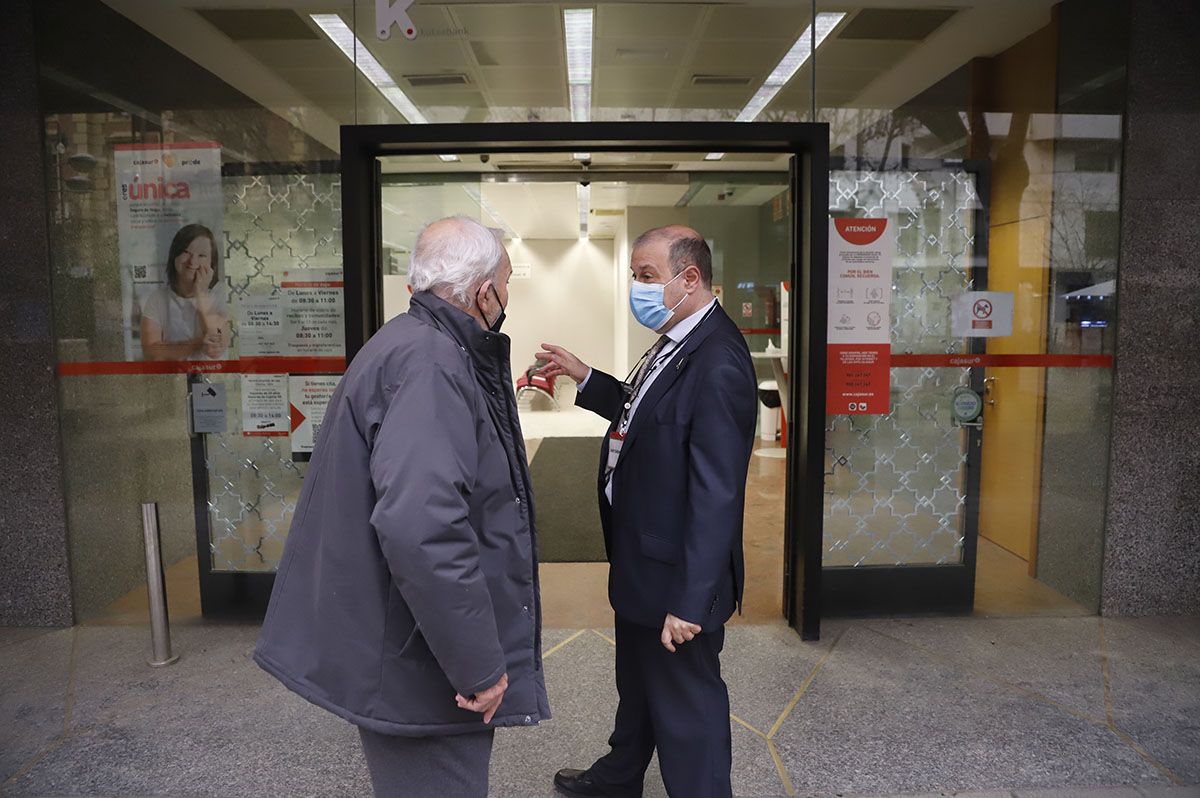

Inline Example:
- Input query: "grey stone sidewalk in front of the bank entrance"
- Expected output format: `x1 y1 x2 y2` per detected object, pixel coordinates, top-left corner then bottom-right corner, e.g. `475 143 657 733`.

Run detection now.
0 618 1200 798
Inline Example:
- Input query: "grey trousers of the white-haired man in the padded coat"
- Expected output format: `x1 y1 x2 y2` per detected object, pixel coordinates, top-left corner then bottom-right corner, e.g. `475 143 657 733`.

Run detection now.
359 726 494 798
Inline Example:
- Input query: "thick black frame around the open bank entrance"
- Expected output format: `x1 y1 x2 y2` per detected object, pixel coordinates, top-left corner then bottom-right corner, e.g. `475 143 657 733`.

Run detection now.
341 122 829 640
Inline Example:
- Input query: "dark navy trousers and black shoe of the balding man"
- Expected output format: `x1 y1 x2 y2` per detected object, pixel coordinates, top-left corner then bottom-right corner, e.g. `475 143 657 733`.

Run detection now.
590 616 733 798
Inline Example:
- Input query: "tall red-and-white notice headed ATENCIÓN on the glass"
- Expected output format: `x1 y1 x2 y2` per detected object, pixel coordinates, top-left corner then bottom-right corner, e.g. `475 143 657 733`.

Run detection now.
826 218 895 415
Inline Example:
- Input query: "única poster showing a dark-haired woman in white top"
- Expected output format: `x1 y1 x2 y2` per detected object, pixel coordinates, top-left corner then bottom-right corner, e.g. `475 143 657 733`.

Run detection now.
114 142 229 360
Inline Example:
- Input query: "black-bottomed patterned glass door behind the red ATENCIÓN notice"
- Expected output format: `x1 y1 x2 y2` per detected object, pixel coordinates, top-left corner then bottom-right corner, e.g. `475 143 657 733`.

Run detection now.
823 161 988 614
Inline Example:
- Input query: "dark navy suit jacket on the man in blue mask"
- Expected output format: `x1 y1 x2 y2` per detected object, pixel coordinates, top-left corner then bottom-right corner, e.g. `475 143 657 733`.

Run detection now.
575 306 757 631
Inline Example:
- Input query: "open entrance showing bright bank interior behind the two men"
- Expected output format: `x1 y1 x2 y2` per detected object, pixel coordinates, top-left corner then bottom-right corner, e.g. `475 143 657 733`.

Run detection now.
369 151 793 628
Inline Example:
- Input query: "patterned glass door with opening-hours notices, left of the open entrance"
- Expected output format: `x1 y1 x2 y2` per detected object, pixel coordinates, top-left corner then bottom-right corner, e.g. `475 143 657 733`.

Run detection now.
186 161 344 617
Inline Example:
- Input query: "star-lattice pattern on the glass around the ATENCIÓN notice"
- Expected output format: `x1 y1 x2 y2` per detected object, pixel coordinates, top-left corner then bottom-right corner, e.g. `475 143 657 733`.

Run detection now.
823 169 985 568
